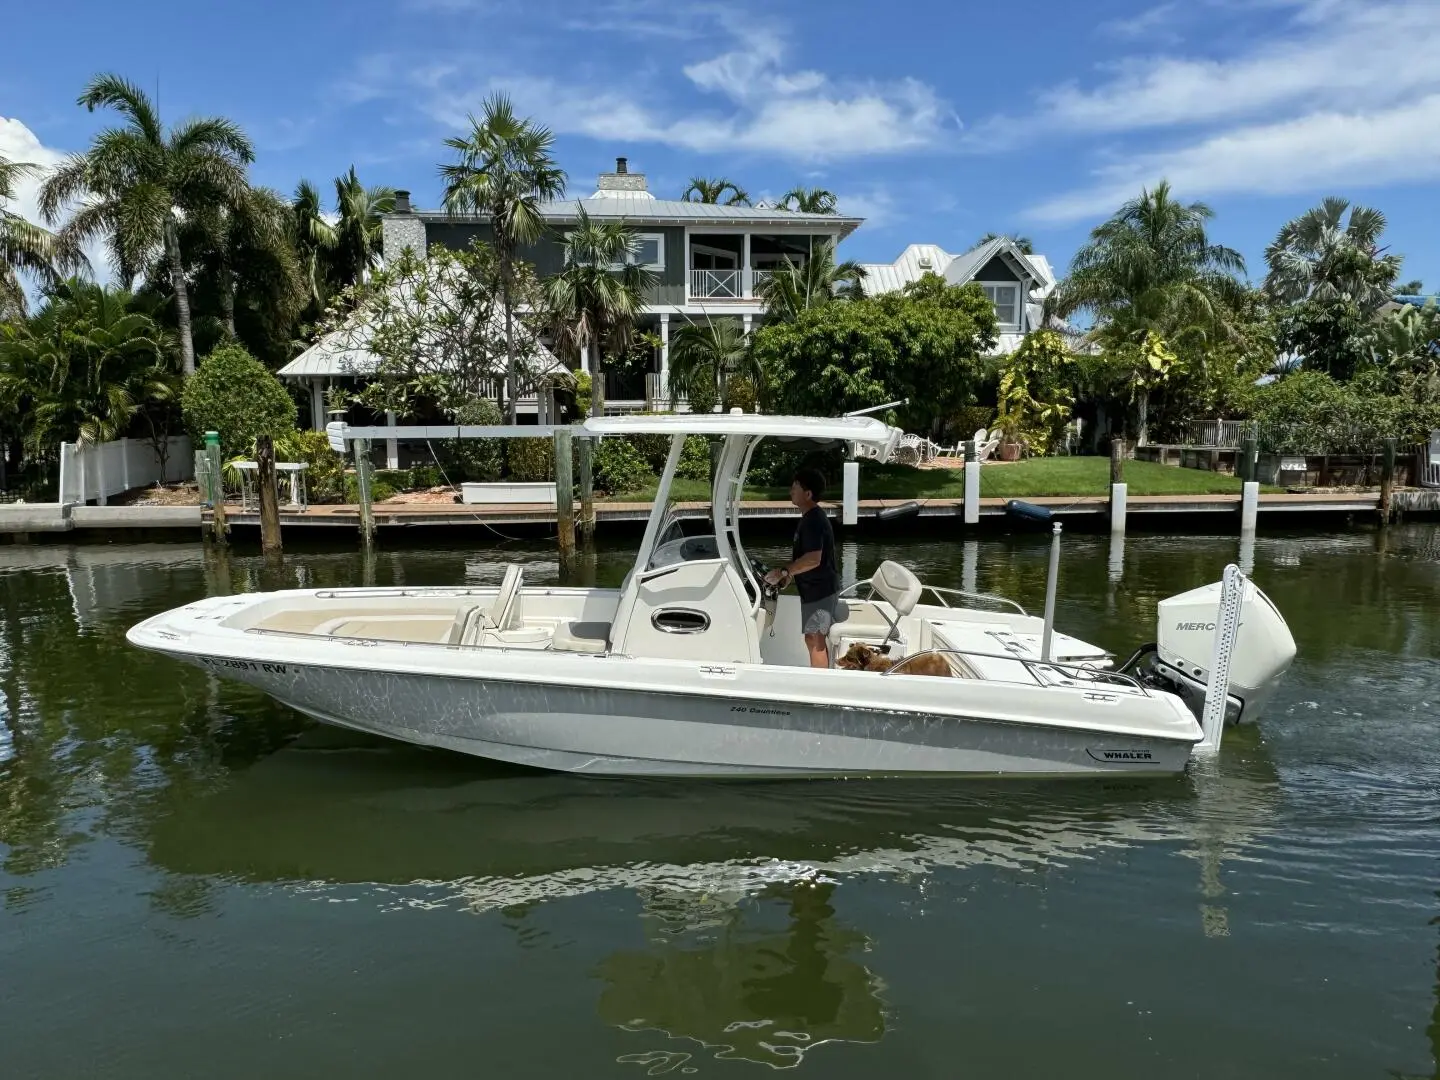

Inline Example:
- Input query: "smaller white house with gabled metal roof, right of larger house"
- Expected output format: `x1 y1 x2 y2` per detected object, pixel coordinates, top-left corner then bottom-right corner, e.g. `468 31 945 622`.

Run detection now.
863 236 1056 356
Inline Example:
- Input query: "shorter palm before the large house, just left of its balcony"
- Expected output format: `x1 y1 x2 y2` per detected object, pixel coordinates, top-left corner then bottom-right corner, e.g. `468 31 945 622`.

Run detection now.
544 204 655 416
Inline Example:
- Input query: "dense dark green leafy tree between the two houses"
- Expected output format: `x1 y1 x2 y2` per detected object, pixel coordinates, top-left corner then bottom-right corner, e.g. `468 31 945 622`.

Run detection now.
752 274 996 431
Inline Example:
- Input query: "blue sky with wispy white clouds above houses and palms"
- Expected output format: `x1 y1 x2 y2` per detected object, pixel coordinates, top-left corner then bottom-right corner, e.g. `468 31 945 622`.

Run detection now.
0 0 1440 287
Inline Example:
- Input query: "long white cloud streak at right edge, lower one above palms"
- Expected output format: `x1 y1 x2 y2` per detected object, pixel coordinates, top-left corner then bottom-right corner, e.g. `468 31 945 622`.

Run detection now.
1028 94 1440 222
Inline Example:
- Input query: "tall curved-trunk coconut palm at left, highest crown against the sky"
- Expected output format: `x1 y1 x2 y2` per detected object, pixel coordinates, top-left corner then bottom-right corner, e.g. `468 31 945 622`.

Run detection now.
40 75 255 376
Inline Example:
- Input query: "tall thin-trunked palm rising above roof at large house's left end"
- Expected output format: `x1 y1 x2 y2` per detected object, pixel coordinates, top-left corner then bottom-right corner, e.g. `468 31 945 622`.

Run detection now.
441 94 564 423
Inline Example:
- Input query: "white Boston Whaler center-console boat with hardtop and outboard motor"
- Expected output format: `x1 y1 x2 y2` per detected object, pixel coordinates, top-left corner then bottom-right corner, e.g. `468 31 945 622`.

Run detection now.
128 415 1295 776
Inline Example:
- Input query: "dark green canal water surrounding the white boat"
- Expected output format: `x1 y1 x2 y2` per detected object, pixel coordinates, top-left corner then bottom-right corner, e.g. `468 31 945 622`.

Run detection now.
0 527 1440 1080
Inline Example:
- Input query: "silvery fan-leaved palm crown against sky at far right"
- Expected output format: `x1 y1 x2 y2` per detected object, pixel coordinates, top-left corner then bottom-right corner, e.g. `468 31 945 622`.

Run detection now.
1264 196 1403 314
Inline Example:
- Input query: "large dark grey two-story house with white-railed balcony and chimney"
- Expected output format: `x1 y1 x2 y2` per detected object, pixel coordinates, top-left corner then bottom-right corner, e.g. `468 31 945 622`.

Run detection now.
383 157 861 412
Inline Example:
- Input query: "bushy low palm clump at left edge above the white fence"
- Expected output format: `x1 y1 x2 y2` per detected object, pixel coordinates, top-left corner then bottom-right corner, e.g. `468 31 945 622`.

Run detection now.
0 278 173 456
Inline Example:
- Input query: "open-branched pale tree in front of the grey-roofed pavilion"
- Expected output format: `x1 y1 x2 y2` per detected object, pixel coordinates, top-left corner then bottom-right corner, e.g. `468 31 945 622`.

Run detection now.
323 240 550 418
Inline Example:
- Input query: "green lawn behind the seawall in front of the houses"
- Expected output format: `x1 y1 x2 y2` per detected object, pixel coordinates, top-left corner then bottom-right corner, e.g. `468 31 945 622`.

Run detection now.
604 458 1280 503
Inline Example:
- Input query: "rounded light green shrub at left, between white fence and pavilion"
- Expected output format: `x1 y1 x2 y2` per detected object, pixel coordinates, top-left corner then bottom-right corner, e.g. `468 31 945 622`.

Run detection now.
181 344 295 458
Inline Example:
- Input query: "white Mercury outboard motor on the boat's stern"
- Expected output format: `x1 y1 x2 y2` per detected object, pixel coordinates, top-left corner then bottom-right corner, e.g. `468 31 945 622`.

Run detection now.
1138 577 1295 723
